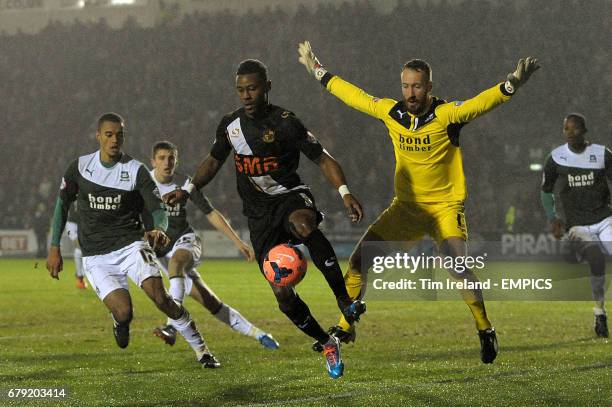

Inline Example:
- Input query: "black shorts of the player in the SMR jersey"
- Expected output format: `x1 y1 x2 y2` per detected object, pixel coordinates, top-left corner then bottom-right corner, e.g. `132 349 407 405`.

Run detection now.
248 190 323 269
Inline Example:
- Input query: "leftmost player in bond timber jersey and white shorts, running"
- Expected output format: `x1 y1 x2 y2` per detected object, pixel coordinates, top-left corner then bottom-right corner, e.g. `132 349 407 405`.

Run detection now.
47 113 219 368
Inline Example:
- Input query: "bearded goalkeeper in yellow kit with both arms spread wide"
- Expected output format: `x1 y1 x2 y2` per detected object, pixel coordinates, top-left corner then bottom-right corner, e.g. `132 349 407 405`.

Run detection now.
298 41 539 363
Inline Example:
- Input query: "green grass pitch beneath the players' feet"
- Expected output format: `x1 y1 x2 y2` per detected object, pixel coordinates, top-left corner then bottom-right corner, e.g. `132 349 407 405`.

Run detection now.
0 259 612 406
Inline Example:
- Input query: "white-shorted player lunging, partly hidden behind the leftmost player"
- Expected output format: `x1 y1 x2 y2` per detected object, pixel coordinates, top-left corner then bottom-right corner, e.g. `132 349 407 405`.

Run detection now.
145 141 279 349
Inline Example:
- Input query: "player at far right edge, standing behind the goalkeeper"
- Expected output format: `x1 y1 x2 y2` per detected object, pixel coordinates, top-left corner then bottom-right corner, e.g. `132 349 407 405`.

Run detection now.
540 113 612 338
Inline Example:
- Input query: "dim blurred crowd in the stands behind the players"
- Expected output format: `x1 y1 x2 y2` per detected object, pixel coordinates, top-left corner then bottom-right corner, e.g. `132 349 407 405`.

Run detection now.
0 0 612 241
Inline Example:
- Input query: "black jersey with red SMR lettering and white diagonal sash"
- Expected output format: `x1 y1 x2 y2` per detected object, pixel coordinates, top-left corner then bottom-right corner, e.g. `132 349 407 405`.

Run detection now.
211 105 323 217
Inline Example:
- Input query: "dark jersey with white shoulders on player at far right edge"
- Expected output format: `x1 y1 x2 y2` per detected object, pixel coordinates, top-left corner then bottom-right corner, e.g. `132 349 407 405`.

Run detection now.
542 144 612 228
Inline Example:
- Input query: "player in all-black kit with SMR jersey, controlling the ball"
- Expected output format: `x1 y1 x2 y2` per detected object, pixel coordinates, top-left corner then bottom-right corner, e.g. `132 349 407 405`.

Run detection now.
164 59 365 378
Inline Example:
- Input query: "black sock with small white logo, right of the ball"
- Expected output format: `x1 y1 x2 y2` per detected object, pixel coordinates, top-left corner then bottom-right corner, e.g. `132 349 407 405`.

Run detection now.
304 229 351 306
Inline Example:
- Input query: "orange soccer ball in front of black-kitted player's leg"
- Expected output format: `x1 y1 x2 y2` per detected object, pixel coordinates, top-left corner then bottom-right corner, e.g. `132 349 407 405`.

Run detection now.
264 243 307 287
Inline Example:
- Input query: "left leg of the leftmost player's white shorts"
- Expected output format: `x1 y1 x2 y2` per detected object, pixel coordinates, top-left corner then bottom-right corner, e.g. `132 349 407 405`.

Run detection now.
83 251 128 301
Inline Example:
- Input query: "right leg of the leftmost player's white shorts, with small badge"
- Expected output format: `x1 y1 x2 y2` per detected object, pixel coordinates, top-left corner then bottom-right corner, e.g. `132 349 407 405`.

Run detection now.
120 240 163 289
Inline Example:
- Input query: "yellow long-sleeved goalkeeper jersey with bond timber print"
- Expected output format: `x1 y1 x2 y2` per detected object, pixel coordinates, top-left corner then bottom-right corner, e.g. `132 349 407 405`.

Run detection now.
321 73 510 202
